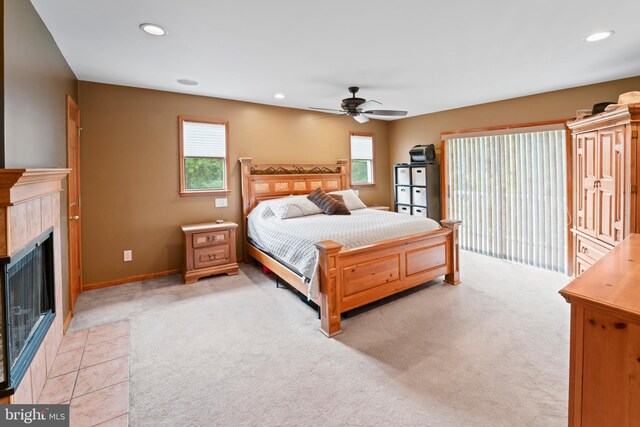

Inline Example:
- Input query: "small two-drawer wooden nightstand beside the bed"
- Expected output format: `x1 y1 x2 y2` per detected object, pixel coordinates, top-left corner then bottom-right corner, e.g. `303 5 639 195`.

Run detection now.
181 221 238 284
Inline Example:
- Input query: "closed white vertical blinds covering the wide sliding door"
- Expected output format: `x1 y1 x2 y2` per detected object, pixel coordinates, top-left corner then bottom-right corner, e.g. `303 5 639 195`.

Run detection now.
445 128 568 273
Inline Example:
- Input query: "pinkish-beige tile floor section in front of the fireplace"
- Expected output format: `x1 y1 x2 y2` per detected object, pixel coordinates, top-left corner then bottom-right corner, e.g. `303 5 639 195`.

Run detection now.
38 320 129 427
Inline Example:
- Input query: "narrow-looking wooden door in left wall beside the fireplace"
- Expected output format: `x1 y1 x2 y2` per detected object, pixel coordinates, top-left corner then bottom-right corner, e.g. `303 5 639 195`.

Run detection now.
67 96 82 309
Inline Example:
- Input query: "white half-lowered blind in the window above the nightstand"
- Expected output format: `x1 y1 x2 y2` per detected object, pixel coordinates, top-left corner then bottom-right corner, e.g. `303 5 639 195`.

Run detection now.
182 121 227 158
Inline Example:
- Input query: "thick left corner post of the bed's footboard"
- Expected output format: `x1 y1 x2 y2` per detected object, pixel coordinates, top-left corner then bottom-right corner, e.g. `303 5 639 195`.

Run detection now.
316 240 342 337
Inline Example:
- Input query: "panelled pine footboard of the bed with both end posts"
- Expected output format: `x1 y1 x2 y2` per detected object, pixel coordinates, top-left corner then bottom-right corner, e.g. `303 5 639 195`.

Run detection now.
316 220 461 337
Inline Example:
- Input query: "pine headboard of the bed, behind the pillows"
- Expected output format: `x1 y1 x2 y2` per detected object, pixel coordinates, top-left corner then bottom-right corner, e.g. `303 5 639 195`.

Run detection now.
239 157 351 227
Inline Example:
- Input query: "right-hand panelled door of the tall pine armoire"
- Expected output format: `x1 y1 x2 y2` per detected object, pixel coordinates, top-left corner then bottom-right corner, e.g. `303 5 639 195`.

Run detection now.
594 126 625 245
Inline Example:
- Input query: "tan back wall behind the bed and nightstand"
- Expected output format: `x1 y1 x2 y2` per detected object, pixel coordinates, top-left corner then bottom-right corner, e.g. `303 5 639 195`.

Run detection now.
79 82 391 284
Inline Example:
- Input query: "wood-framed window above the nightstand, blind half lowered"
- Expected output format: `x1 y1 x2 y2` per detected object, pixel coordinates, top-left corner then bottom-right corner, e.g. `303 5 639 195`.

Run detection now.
178 117 229 196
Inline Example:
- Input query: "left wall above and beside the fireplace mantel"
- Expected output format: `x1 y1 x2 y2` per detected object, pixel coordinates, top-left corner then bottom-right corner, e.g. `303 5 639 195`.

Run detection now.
4 0 78 315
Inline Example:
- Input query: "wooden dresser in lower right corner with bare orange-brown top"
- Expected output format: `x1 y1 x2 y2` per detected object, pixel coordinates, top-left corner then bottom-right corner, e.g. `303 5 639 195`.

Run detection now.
560 234 640 426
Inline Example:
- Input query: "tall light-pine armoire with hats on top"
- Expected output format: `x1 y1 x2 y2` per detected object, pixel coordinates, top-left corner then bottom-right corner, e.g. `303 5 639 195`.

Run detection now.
567 104 640 276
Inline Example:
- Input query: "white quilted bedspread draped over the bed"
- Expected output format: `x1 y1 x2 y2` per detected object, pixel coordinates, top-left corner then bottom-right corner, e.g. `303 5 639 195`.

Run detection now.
248 201 440 298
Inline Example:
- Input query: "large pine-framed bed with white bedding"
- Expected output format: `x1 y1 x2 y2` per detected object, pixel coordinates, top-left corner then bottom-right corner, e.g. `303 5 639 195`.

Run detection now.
240 157 461 337
